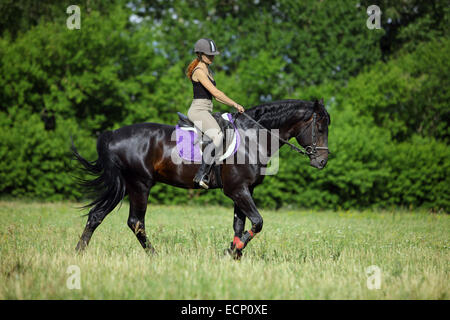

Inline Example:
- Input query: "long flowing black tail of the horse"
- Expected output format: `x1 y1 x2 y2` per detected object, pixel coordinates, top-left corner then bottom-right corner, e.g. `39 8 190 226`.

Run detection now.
71 131 126 217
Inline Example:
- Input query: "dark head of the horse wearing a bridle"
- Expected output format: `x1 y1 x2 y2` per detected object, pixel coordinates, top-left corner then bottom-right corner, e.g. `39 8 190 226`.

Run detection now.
295 99 330 169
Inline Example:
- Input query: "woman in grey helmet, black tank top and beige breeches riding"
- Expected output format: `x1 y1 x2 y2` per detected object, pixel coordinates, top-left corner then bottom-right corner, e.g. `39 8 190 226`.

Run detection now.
186 38 245 189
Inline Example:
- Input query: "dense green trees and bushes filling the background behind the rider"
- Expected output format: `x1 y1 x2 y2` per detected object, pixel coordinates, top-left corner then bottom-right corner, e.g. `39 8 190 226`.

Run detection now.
0 0 450 212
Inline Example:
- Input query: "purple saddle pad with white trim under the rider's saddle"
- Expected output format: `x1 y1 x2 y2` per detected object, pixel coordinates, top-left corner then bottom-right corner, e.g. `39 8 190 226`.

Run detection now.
175 113 240 162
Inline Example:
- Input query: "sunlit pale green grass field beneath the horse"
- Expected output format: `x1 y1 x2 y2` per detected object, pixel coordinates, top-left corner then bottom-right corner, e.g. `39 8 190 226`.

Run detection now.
0 201 450 299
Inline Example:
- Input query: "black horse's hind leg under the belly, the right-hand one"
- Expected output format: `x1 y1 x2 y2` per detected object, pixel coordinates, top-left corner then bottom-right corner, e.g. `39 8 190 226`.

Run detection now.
128 182 156 254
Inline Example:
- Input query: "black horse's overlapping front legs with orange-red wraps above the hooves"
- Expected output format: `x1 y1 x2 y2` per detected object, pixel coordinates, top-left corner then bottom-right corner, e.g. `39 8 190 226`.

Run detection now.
224 187 263 255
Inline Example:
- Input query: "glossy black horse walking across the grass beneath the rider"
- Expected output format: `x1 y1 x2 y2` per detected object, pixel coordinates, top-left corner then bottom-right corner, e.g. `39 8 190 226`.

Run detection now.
72 100 330 258
